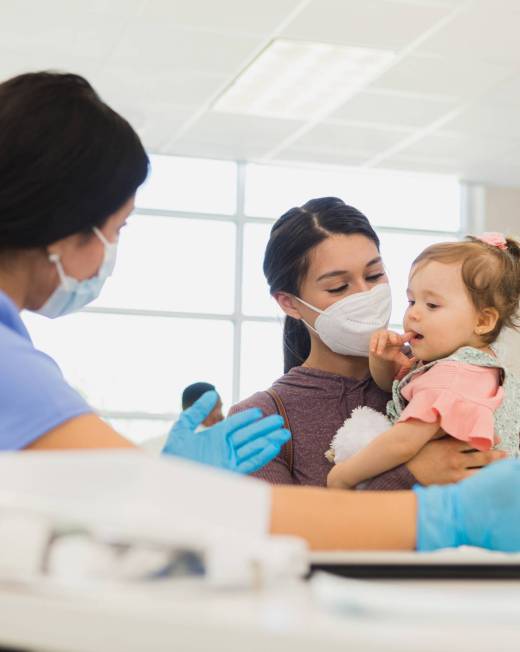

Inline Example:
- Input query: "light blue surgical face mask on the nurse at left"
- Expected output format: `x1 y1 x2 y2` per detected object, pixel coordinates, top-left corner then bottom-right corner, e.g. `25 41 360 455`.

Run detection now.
34 227 117 319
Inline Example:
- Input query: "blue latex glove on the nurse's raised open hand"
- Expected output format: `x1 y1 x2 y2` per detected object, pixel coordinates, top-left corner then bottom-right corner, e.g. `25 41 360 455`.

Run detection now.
162 391 291 473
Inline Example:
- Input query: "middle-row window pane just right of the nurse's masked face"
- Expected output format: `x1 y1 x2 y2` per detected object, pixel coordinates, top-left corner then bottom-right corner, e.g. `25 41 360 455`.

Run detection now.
93 215 236 314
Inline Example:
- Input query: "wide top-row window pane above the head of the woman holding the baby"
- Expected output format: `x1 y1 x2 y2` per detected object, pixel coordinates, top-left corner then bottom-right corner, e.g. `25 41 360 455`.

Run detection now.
245 165 460 231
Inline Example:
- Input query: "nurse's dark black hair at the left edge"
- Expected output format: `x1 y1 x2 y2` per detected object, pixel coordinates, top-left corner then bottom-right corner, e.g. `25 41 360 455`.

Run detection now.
0 72 149 252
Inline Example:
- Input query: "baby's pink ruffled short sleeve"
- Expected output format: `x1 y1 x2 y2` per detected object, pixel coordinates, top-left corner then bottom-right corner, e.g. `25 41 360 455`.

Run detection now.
399 361 503 450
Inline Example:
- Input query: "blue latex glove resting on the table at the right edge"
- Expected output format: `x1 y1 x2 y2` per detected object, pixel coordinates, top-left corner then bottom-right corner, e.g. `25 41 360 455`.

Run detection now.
413 460 520 552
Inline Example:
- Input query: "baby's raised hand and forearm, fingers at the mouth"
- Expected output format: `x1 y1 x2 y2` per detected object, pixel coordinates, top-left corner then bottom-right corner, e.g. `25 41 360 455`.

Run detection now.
368 330 413 392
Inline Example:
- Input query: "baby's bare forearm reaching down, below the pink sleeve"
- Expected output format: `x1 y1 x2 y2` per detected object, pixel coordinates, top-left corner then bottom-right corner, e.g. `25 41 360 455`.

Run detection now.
327 419 440 489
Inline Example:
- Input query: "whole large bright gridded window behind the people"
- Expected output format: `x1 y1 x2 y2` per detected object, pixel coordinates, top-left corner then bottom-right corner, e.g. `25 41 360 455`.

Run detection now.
24 156 462 442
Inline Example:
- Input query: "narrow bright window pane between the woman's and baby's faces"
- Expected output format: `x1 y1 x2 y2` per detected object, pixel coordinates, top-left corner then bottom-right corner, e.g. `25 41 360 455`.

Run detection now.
379 233 458 326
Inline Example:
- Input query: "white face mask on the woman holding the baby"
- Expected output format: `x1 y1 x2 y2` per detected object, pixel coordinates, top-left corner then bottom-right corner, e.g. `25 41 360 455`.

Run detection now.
296 283 392 357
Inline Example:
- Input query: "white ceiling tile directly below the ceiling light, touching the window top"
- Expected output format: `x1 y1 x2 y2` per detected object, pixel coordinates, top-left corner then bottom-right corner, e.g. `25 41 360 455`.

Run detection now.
171 111 302 159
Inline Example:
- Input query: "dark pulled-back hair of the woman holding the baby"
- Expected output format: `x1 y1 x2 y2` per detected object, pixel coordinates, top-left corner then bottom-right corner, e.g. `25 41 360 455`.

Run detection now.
264 197 379 373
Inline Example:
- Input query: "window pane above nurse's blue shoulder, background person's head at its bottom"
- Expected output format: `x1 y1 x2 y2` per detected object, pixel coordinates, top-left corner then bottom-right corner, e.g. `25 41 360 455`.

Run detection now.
24 313 233 413
